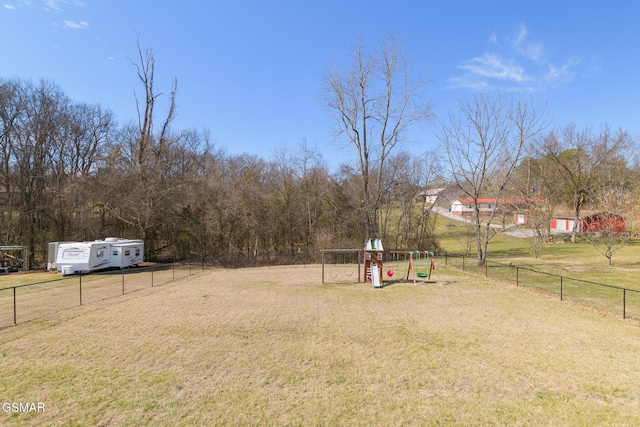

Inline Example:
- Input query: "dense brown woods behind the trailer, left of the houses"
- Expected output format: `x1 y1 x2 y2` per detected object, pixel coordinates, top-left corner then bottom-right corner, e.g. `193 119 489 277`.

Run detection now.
0 74 440 267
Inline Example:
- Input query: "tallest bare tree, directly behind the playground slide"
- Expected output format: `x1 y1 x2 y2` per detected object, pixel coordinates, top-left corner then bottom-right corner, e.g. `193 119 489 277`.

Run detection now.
324 39 431 241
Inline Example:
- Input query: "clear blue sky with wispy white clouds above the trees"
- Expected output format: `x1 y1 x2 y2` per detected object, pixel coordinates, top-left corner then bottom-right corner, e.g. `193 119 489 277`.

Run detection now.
0 0 640 169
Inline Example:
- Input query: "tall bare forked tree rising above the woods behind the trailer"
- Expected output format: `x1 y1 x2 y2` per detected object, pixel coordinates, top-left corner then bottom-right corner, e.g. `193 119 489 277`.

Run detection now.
99 41 182 255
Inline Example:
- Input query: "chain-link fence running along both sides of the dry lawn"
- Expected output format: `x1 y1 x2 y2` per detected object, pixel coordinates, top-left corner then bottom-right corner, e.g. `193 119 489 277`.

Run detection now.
10 252 640 329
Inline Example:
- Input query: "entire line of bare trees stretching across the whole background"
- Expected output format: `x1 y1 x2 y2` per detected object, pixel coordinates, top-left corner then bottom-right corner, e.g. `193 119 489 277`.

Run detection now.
0 39 640 267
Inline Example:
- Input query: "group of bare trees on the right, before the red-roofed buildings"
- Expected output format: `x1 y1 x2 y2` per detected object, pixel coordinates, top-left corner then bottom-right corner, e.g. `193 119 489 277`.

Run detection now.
437 93 640 266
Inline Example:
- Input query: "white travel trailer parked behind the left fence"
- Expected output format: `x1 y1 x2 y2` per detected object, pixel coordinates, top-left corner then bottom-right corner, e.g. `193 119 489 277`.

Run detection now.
56 237 144 276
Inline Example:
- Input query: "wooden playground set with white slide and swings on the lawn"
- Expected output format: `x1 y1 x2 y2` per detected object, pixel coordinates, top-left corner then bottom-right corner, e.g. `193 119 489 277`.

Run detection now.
321 239 439 288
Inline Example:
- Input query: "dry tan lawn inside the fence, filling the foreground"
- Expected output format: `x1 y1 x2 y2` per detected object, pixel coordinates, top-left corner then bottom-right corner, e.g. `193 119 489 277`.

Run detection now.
0 266 640 426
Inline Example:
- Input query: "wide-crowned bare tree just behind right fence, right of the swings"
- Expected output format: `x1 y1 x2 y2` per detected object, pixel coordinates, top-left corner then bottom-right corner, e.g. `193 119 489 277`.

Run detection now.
438 94 546 266
